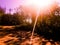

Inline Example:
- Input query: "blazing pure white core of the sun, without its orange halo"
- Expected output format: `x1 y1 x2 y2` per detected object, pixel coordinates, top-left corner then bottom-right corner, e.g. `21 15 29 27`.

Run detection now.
25 0 54 8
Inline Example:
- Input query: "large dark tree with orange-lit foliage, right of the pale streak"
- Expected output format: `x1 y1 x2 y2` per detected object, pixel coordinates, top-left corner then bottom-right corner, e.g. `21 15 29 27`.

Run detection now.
35 7 60 41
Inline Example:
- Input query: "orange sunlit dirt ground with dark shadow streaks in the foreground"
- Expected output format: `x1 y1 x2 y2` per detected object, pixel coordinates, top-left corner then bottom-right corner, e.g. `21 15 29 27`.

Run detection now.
0 31 60 45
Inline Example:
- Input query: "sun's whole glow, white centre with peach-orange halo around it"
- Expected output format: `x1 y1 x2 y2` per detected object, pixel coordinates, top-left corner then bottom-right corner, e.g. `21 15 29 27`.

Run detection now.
23 0 55 13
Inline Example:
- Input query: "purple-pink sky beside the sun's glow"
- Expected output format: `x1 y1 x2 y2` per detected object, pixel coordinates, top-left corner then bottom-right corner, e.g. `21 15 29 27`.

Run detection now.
0 0 60 12
